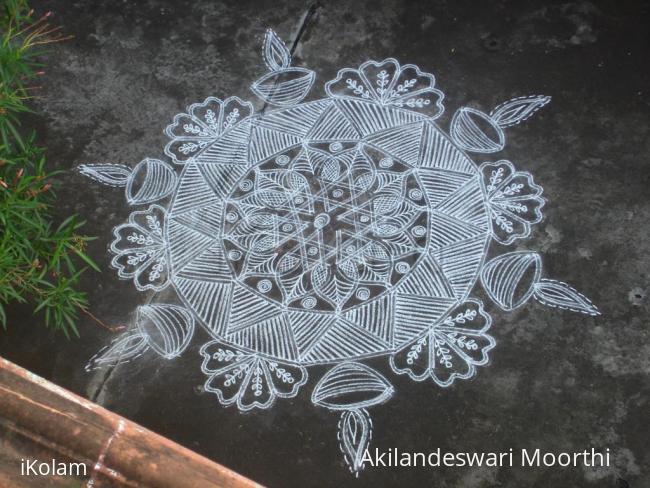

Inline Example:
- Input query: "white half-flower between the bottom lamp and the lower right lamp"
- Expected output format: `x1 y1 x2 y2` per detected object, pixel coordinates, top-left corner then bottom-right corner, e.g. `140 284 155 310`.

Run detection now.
390 300 496 387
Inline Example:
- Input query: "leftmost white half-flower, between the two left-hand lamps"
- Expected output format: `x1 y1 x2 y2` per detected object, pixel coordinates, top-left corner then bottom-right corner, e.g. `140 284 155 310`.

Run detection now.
110 205 169 291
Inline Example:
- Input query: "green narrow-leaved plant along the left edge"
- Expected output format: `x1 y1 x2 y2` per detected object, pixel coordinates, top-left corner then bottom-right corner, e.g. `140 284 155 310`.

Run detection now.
0 0 99 336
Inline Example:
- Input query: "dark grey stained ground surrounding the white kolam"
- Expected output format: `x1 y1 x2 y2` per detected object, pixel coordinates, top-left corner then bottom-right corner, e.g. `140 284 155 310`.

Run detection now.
0 0 650 488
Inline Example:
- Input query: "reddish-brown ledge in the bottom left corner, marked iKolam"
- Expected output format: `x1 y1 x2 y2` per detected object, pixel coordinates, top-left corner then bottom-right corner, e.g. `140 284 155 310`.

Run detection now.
0 358 261 488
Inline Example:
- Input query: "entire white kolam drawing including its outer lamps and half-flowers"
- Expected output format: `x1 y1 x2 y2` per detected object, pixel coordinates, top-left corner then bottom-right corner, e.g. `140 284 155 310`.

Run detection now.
81 31 598 475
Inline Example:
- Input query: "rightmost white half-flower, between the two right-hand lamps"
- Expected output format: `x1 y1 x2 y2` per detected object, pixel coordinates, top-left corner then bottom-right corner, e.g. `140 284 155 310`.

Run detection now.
479 160 545 245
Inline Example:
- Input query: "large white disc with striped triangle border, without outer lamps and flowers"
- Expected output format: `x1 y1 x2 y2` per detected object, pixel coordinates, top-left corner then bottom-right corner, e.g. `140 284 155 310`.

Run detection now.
166 98 490 365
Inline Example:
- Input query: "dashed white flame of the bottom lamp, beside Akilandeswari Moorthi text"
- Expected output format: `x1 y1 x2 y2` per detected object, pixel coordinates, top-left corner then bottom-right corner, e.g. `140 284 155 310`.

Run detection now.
338 409 372 477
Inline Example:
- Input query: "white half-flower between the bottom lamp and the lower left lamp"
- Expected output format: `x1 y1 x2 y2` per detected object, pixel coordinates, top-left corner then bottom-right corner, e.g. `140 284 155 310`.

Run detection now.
200 341 307 411
